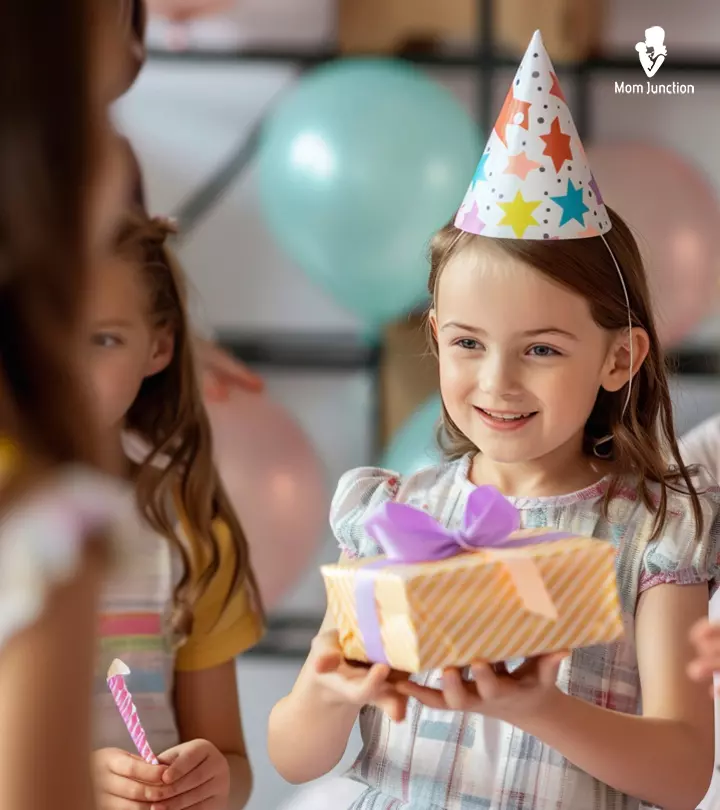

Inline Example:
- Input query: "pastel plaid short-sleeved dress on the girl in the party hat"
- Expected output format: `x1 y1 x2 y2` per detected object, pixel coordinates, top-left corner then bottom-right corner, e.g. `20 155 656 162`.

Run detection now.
331 456 720 810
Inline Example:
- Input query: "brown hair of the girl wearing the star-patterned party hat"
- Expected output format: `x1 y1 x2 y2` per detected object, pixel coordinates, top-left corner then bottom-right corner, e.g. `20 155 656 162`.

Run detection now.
428 208 702 538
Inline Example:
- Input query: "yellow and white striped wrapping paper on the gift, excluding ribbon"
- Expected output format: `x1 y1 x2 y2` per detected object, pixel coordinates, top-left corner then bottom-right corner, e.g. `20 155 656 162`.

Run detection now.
321 529 623 673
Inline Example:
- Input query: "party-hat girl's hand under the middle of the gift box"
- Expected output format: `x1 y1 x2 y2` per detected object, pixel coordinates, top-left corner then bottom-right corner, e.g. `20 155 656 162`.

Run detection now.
397 653 567 723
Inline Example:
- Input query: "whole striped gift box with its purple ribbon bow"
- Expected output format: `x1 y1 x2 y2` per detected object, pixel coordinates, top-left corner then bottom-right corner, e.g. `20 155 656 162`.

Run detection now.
321 487 623 673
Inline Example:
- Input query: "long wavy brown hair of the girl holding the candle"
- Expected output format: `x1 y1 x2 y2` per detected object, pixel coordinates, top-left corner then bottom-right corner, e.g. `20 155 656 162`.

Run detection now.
119 209 262 640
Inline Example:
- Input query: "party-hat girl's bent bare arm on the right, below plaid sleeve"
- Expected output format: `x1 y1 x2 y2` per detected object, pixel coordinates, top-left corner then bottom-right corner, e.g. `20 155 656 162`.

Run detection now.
517 584 714 810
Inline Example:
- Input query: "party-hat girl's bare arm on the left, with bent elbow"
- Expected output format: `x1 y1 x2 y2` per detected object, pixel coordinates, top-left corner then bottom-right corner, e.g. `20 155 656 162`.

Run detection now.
268 614 361 784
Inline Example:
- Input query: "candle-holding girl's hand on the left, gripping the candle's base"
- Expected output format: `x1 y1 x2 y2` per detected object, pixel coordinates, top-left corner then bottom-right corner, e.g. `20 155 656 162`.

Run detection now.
93 748 171 810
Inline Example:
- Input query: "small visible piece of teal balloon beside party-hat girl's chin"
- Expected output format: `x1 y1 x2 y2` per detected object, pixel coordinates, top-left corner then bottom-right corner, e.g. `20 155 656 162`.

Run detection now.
380 395 442 475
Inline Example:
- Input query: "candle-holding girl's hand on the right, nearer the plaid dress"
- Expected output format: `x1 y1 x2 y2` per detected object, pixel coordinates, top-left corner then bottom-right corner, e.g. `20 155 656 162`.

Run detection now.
159 740 230 810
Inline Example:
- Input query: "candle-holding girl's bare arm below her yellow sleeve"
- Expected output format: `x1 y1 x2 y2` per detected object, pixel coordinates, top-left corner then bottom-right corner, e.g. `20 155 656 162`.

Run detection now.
175 660 253 810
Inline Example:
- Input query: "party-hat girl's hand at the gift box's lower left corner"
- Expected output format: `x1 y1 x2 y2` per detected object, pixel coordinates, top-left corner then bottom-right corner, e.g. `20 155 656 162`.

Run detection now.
310 630 409 723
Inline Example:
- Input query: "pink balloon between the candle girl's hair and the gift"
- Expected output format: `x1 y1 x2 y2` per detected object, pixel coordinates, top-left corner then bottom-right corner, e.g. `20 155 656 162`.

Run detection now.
206 390 329 608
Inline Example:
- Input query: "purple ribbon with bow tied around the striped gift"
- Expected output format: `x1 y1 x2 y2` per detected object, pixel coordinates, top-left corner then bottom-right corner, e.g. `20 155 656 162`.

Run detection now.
355 486 570 664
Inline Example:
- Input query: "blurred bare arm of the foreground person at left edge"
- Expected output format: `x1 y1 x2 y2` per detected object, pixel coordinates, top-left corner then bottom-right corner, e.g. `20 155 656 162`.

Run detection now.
0 541 104 810
